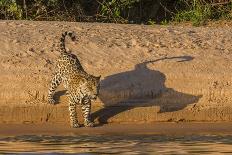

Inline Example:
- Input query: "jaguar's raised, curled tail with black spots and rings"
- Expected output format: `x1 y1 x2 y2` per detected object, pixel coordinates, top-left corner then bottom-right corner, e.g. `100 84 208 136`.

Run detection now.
60 31 76 54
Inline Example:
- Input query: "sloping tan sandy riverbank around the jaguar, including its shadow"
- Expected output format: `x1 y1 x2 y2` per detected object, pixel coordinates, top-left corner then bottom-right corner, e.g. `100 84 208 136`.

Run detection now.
0 21 232 124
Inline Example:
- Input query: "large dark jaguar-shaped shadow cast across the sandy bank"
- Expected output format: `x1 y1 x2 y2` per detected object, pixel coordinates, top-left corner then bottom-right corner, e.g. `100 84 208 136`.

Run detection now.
92 56 202 124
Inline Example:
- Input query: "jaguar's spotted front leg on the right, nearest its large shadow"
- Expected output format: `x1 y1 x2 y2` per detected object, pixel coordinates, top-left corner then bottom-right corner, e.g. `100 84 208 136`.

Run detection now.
81 99 94 127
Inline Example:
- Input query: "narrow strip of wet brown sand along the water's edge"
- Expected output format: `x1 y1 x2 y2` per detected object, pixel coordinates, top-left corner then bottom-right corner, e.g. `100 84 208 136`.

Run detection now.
0 122 232 136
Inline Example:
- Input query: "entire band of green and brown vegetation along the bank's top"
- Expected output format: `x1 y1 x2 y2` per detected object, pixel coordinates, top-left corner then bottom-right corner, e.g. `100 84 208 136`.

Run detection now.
0 0 232 25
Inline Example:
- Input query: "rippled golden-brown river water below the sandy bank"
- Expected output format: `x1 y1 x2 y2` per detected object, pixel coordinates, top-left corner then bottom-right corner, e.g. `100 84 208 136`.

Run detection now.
0 135 232 155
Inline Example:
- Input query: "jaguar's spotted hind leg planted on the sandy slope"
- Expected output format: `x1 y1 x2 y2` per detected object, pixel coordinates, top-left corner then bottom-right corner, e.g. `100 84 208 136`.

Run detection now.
48 73 62 104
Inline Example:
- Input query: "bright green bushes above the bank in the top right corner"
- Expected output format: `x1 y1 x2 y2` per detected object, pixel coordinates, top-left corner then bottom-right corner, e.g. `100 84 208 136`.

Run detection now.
173 0 232 25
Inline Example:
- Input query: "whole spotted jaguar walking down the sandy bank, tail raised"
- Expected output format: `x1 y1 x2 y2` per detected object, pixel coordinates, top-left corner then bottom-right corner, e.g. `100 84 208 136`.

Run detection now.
48 31 100 128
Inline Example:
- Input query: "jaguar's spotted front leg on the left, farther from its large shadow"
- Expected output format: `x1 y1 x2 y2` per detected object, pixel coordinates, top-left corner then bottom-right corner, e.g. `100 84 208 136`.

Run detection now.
69 97 80 128
